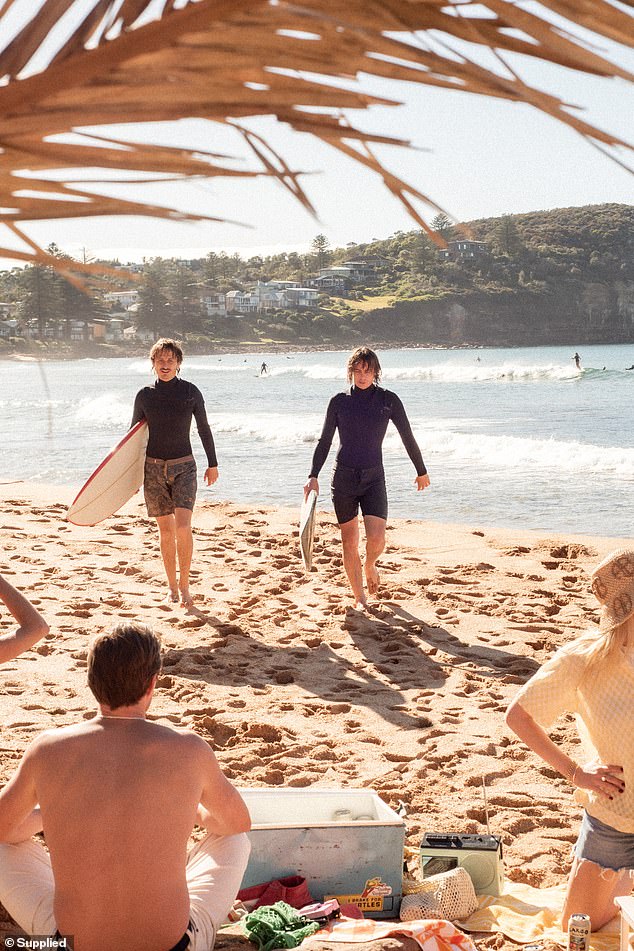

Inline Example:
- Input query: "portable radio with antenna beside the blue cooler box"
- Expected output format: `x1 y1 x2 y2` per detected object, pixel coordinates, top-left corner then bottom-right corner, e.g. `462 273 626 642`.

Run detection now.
420 832 504 895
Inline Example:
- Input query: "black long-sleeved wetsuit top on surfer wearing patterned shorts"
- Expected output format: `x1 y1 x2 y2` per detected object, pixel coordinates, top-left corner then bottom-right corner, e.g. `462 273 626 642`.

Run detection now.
131 376 218 468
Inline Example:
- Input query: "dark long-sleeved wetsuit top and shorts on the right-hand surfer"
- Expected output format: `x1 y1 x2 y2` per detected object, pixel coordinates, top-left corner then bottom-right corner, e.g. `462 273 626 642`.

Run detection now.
310 385 427 524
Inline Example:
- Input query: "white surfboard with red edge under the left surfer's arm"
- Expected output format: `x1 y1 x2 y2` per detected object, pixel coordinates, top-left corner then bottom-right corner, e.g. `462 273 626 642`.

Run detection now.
66 419 149 525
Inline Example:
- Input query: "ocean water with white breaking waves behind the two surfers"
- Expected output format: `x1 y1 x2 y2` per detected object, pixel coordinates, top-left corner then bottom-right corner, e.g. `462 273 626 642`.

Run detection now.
0 346 634 536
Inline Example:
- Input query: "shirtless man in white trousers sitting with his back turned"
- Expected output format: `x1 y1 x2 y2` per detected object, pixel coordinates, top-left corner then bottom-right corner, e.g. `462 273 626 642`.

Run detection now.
0 623 251 951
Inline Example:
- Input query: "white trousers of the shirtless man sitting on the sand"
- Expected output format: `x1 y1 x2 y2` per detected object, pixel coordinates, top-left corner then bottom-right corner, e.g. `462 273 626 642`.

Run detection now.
0 834 251 951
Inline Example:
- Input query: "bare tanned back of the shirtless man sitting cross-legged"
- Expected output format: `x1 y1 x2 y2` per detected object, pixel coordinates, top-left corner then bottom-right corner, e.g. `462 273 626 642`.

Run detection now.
33 717 212 951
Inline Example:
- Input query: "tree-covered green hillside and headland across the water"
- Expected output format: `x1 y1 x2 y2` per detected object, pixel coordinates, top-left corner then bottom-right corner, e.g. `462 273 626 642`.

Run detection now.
0 204 634 352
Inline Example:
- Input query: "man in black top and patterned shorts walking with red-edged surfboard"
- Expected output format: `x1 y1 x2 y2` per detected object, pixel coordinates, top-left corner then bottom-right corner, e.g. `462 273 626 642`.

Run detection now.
131 338 218 607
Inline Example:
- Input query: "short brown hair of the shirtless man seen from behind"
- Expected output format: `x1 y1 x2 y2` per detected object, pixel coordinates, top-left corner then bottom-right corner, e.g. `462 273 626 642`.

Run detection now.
88 621 161 710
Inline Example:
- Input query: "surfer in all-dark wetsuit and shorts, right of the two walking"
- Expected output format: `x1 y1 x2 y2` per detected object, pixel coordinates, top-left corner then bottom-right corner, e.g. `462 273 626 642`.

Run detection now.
304 347 429 610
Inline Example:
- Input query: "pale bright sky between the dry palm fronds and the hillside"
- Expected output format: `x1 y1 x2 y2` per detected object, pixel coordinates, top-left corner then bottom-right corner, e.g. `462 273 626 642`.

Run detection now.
4 13 634 262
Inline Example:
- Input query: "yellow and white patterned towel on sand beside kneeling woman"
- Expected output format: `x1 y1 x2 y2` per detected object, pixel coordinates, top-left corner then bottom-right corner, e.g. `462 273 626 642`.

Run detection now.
459 882 619 951
